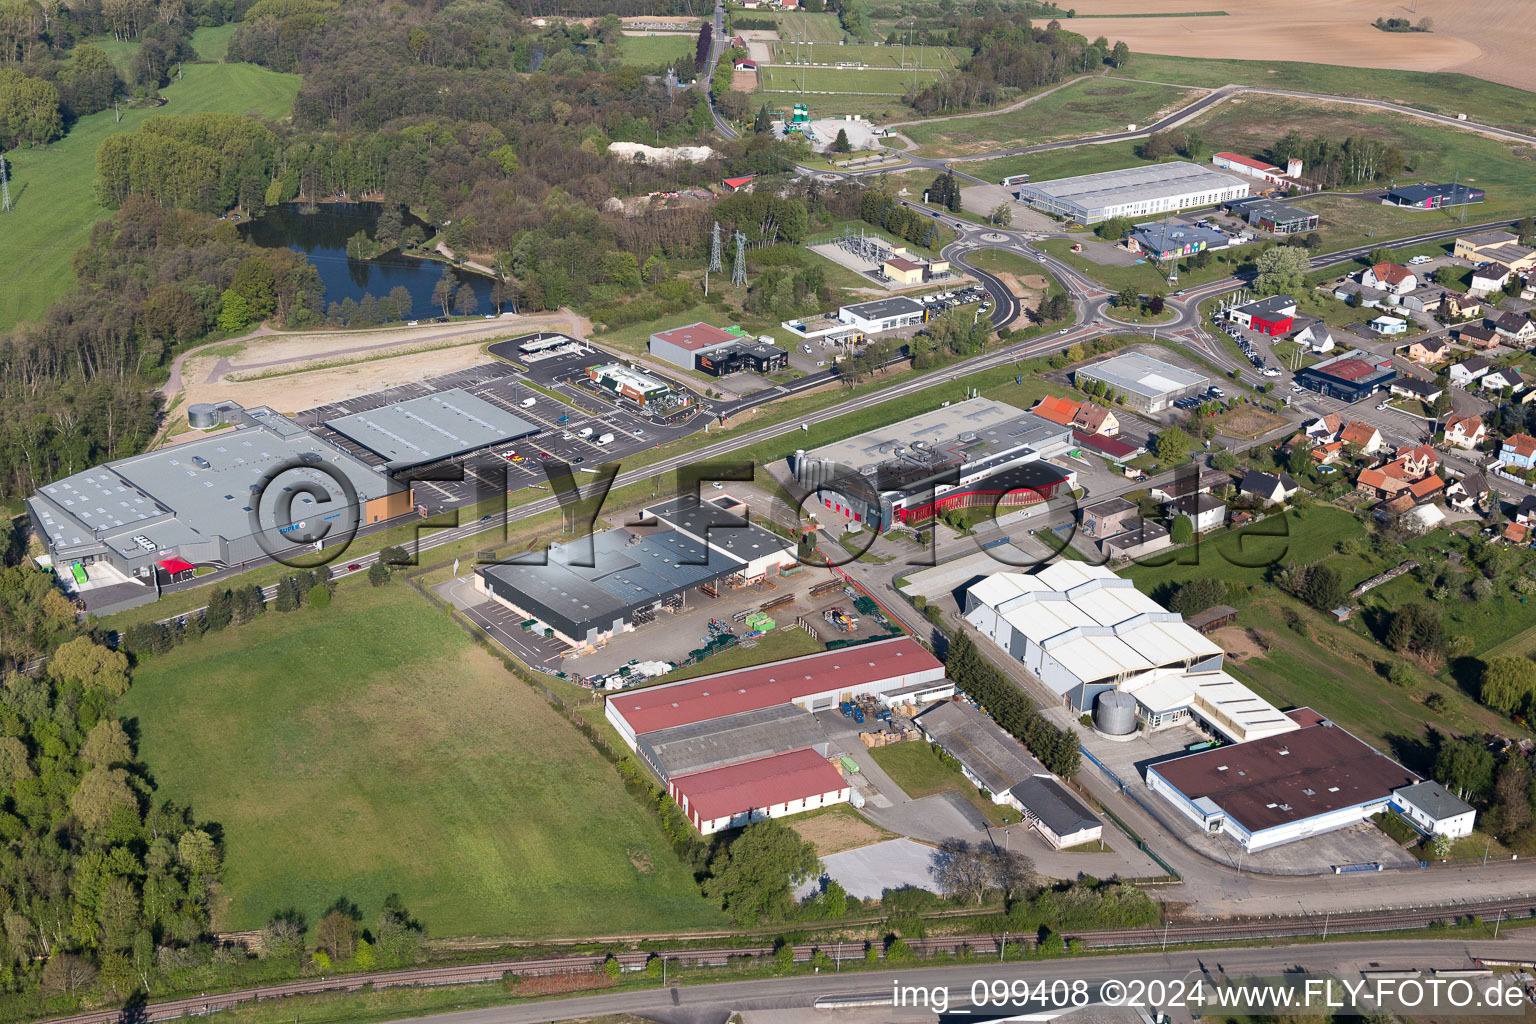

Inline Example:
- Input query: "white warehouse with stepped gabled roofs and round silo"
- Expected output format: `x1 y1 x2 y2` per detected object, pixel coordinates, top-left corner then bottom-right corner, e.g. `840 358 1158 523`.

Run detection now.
965 562 1296 743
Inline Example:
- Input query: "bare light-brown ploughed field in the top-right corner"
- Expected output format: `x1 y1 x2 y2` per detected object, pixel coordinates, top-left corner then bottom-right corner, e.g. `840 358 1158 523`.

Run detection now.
1077 0 1536 89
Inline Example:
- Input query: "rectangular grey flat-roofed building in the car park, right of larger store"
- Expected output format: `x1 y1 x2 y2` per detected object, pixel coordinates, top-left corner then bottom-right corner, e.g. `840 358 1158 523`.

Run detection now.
326 388 539 470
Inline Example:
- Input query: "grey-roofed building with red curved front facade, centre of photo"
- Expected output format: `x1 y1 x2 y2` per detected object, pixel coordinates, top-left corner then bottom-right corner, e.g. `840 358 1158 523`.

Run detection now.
790 398 1077 531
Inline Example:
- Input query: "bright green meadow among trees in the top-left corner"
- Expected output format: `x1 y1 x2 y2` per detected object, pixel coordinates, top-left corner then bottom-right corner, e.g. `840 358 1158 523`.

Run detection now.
0 64 300 330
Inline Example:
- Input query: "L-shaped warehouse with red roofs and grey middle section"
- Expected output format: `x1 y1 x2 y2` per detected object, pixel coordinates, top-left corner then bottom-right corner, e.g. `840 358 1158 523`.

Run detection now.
605 637 952 835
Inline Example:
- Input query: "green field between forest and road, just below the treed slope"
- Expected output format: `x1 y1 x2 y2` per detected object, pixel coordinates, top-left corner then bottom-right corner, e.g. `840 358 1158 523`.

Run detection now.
902 78 1200 157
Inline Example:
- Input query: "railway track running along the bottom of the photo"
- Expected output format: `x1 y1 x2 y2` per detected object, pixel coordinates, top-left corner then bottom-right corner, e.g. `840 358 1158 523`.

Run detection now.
33 894 1536 1024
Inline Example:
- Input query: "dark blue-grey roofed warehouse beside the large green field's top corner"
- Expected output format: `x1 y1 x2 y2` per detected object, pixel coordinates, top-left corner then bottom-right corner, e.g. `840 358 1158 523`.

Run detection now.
475 496 794 649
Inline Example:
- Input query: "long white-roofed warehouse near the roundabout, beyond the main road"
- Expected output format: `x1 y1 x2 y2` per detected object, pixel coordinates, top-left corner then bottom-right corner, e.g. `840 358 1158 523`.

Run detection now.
1018 161 1252 224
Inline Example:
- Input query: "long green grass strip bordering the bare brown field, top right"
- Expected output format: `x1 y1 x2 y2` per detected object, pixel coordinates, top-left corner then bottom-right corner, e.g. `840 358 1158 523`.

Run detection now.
1111 48 1536 130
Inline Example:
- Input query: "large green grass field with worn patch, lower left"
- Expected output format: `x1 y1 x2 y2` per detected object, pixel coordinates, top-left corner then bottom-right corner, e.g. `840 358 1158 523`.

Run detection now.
120 582 720 938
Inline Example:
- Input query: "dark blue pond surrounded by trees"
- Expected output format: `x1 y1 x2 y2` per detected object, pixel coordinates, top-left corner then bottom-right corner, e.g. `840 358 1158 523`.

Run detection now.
241 203 495 319
